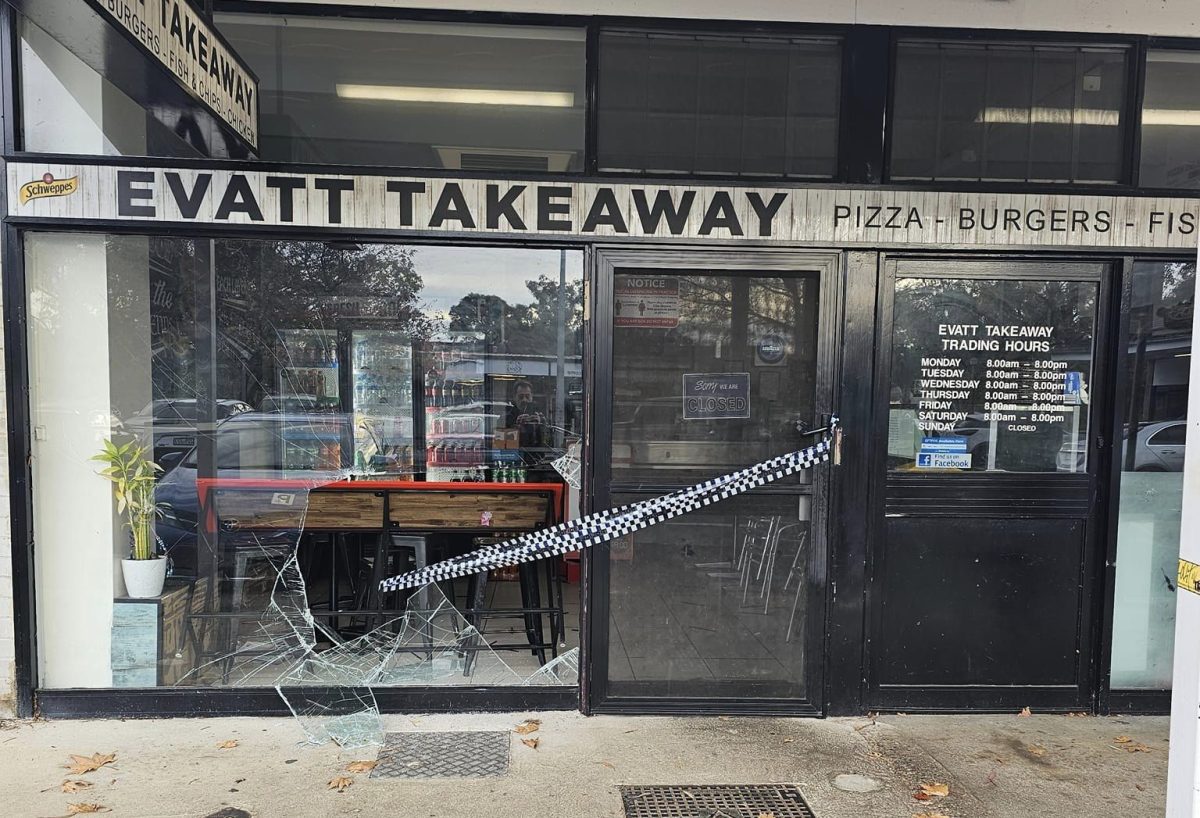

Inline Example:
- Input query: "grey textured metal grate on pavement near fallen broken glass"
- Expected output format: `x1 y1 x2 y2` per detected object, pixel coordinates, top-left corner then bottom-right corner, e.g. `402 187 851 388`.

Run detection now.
371 730 508 772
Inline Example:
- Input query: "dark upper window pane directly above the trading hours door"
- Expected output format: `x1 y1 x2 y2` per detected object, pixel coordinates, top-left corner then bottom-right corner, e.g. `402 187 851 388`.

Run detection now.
890 42 1127 182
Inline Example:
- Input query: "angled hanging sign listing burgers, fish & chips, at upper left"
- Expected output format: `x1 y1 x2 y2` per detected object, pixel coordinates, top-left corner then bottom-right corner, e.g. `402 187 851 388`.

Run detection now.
89 0 258 150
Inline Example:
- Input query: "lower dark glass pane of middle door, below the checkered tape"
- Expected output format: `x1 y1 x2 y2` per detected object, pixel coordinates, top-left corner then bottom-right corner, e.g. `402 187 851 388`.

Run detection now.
608 494 817 699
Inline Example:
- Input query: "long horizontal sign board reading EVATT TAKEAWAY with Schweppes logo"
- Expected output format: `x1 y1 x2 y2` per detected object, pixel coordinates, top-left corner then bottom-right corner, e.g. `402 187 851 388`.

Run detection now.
7 162 1200 249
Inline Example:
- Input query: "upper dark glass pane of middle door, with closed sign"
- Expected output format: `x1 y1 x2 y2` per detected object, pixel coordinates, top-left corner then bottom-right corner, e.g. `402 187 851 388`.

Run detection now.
612 269 820 486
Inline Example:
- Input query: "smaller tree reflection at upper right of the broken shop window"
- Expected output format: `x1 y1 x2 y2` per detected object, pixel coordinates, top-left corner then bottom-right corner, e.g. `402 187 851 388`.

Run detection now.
448 276 583 355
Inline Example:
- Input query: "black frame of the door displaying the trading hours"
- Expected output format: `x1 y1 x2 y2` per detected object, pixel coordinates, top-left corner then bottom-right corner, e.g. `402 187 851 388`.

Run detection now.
863 253 1122 712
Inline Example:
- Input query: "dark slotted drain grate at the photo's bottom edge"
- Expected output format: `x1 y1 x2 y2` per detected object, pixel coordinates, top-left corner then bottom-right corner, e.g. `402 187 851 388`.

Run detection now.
620 784 815 818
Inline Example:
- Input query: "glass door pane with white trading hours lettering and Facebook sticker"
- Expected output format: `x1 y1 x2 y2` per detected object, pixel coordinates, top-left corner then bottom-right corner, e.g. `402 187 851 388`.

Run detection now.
888 277 1098 474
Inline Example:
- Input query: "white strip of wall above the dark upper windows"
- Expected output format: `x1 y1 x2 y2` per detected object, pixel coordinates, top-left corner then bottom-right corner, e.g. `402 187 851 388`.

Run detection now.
258 0 1200 37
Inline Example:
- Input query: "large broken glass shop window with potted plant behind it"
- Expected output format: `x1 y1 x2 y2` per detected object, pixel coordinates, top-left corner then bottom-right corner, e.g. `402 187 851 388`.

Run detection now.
25 234 584 686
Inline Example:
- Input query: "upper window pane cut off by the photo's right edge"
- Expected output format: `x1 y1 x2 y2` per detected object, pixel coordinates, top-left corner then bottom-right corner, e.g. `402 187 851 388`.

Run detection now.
1140 52 1200 188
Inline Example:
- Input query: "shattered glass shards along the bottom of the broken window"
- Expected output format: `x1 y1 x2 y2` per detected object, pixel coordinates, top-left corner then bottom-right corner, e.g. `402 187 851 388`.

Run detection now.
180 515 578 748
